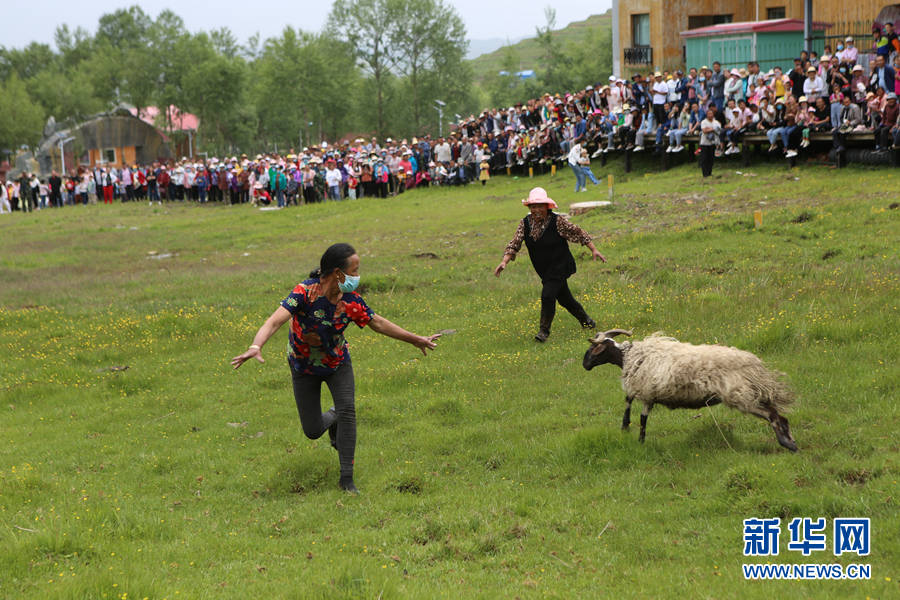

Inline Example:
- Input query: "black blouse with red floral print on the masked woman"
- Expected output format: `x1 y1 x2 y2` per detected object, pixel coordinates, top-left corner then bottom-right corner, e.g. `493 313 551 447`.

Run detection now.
281 279 375 375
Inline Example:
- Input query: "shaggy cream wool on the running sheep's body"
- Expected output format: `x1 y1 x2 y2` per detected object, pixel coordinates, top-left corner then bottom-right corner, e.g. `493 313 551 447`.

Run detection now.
622 334 794 417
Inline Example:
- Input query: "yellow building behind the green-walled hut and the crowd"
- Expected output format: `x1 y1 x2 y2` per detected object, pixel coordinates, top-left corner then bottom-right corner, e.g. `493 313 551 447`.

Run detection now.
613 0 900 77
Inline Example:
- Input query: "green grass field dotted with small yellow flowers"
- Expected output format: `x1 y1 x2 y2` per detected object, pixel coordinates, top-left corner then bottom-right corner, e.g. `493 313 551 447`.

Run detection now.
0 161 900 600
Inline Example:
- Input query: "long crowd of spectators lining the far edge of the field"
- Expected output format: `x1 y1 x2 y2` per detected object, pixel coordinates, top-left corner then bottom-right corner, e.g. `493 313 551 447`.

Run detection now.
0 23 900 213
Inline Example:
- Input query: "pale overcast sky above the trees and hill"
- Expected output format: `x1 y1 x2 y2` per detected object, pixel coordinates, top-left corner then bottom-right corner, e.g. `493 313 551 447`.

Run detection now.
0 0 612 48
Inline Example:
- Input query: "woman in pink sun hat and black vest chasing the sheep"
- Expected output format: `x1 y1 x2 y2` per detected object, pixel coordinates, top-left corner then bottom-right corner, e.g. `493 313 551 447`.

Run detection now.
494 187 606 342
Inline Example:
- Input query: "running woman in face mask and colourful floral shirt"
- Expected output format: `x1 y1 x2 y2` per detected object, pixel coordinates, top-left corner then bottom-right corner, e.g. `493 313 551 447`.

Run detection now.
231 244 440 494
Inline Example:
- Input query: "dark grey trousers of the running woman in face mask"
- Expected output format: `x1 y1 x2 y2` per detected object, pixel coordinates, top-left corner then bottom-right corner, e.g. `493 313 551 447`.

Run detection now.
291 362 356 478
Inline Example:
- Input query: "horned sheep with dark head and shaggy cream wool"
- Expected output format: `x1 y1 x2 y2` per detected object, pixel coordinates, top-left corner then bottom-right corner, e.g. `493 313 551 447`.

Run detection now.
582 329 797 452
